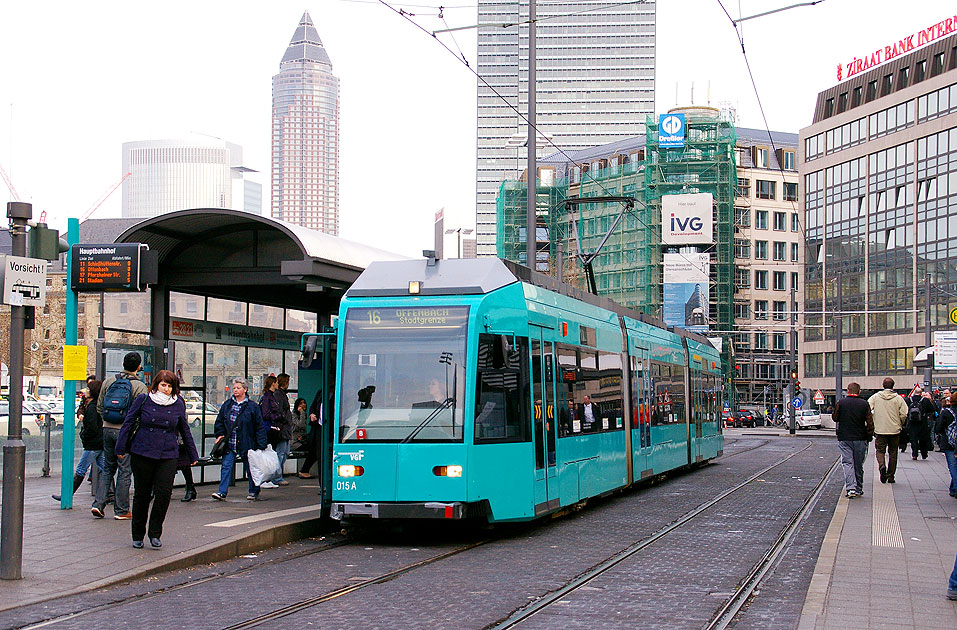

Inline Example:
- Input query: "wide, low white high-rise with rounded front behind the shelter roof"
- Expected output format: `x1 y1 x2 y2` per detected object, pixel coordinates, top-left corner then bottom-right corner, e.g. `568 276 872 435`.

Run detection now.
122 135 262 218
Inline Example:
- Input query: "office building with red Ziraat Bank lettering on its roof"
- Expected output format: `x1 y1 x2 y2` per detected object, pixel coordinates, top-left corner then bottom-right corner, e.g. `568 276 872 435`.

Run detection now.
799 32 957 400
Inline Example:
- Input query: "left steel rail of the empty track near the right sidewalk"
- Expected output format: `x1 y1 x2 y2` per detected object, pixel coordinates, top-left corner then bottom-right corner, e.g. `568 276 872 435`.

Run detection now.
486 444 813 630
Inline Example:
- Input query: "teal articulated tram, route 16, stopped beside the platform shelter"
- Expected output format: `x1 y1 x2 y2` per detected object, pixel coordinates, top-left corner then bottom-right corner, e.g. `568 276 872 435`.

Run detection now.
330 259 723 523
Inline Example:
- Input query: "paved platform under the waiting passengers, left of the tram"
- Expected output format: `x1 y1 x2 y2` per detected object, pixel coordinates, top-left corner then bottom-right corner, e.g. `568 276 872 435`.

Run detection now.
0 475 320 611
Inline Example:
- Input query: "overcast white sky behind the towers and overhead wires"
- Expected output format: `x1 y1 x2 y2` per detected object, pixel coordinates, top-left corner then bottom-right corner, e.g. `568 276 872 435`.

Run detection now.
0 0 954 255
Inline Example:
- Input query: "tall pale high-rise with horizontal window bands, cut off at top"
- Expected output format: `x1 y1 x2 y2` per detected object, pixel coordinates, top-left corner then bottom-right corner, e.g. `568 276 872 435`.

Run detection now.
476 0 655 256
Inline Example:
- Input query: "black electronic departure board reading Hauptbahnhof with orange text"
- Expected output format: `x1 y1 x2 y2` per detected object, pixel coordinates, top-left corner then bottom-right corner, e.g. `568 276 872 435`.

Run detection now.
70 243 156 291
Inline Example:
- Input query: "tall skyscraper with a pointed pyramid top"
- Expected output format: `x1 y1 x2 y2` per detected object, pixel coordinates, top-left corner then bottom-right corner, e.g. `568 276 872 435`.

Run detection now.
271 11 339 235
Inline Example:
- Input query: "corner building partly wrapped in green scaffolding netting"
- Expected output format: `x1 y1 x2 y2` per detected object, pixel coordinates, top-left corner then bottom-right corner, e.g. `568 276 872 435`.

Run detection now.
496 107 803 403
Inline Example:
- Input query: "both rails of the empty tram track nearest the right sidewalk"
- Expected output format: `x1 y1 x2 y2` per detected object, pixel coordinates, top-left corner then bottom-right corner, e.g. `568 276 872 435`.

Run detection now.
483 444 820 630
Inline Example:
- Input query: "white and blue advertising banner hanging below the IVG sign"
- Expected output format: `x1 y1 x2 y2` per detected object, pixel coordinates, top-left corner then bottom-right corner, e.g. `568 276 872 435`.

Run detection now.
663 254 710 333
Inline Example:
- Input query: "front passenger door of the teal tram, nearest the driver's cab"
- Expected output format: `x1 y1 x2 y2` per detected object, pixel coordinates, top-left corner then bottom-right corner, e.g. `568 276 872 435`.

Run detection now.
529 326 559 515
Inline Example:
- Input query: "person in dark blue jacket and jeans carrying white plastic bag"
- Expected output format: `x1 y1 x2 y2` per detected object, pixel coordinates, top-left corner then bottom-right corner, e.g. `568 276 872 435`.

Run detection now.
212 378 268 501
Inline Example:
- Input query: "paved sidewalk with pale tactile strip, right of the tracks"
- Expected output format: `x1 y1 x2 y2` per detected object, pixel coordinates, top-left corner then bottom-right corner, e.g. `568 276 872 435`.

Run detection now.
799 443 957 630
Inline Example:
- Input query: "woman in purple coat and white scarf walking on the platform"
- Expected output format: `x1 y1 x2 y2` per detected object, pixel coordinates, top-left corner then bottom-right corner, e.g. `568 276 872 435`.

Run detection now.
116 370 199 549
